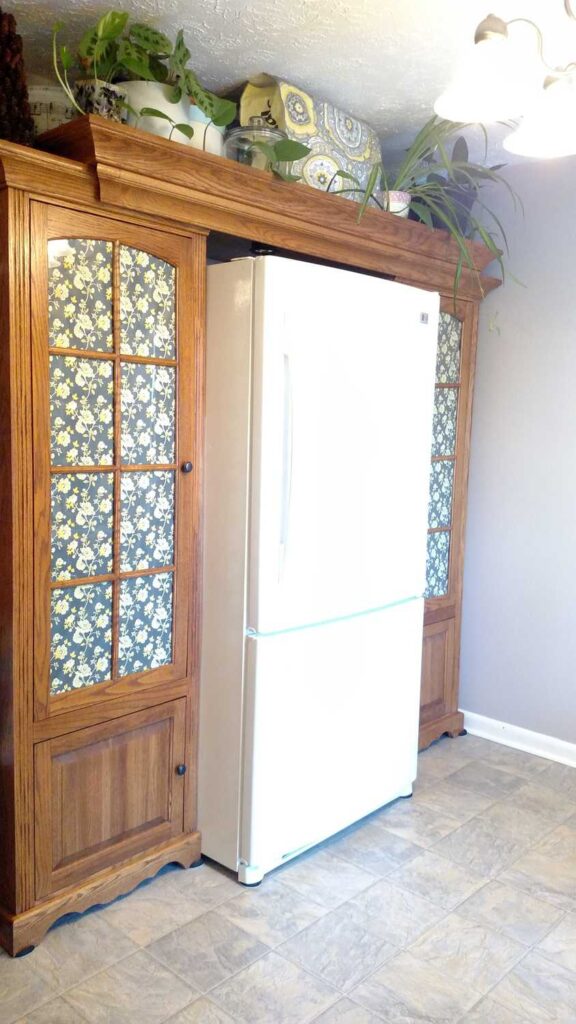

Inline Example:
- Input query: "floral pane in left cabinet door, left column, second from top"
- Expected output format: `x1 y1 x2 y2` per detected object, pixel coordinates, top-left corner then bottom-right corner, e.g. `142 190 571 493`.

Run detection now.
50 355 114 466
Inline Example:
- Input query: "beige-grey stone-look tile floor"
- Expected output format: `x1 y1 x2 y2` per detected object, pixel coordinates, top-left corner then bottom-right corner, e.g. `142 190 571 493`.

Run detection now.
0 736 576 1024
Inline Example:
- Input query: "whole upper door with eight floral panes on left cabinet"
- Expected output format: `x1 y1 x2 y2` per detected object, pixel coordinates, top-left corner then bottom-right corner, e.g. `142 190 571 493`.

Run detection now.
33 206 200 716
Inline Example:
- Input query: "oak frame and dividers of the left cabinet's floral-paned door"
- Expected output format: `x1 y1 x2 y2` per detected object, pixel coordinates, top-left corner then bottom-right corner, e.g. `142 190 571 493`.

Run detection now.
32 203 201 721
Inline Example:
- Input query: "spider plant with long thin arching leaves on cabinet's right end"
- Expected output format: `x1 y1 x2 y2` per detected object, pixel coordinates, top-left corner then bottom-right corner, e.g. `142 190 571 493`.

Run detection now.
329 115 522 294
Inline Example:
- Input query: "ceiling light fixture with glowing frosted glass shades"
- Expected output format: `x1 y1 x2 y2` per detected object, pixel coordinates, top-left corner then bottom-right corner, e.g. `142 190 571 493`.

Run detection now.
434 0 576 158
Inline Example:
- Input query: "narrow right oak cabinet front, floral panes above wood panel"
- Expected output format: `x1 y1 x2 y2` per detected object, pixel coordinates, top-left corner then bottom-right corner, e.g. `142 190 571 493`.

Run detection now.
420 297 478 746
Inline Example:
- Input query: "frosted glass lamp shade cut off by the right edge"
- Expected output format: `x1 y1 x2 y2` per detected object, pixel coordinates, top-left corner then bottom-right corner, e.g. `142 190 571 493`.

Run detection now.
503 77 576 160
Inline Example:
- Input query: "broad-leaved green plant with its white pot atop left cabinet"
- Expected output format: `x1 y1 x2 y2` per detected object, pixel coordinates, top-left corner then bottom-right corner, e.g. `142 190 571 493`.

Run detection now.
53 10 236 140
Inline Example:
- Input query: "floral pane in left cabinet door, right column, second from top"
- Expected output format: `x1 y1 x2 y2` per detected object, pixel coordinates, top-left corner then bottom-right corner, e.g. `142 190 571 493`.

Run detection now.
120 362 176 465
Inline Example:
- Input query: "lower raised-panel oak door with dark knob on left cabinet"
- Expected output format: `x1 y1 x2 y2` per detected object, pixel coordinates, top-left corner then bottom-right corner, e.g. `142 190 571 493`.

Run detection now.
35 698 186 898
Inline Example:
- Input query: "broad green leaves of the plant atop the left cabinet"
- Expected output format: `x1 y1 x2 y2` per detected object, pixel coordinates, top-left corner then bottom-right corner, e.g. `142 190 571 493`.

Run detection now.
52 10 236 128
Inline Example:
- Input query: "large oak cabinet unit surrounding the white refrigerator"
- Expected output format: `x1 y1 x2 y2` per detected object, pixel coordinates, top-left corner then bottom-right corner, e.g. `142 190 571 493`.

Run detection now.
0 117 498 953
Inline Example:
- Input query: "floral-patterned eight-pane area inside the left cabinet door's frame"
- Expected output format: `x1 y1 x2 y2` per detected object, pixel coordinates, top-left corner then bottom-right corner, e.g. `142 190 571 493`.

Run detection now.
48 239 176 695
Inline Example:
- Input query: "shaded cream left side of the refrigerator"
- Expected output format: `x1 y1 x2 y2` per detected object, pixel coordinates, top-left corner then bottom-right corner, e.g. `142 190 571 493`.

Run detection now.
198 261 253 869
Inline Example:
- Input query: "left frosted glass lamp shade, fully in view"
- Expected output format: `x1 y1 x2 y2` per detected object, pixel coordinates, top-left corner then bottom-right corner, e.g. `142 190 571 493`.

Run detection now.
434 35 542 122
